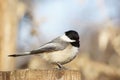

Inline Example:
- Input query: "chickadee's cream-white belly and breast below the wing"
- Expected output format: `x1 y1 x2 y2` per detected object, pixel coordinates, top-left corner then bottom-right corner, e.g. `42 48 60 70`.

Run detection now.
43 45 78 63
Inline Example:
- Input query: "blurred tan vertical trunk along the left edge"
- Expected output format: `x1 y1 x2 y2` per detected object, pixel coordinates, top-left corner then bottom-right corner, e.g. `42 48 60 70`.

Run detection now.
0 0 17 71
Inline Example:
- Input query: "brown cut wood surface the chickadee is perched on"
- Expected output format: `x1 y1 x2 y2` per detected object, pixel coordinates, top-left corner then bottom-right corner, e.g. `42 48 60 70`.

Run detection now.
0 70 81 80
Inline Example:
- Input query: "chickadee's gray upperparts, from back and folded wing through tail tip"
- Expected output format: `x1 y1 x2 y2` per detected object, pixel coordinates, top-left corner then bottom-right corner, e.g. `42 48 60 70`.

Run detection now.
8 39 68 57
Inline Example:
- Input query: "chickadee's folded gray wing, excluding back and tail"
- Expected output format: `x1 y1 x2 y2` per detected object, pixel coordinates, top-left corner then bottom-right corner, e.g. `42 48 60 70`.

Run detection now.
30 43 67 55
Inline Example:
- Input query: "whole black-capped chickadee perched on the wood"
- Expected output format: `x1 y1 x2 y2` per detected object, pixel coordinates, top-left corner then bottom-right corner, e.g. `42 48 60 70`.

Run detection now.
9 30 80 68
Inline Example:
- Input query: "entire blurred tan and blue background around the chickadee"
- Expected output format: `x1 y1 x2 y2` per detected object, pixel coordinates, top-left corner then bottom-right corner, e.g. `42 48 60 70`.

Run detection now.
0 0 120 80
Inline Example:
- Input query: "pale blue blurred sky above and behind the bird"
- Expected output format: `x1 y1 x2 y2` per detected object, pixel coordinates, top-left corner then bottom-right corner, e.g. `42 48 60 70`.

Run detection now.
18 0 120 50
